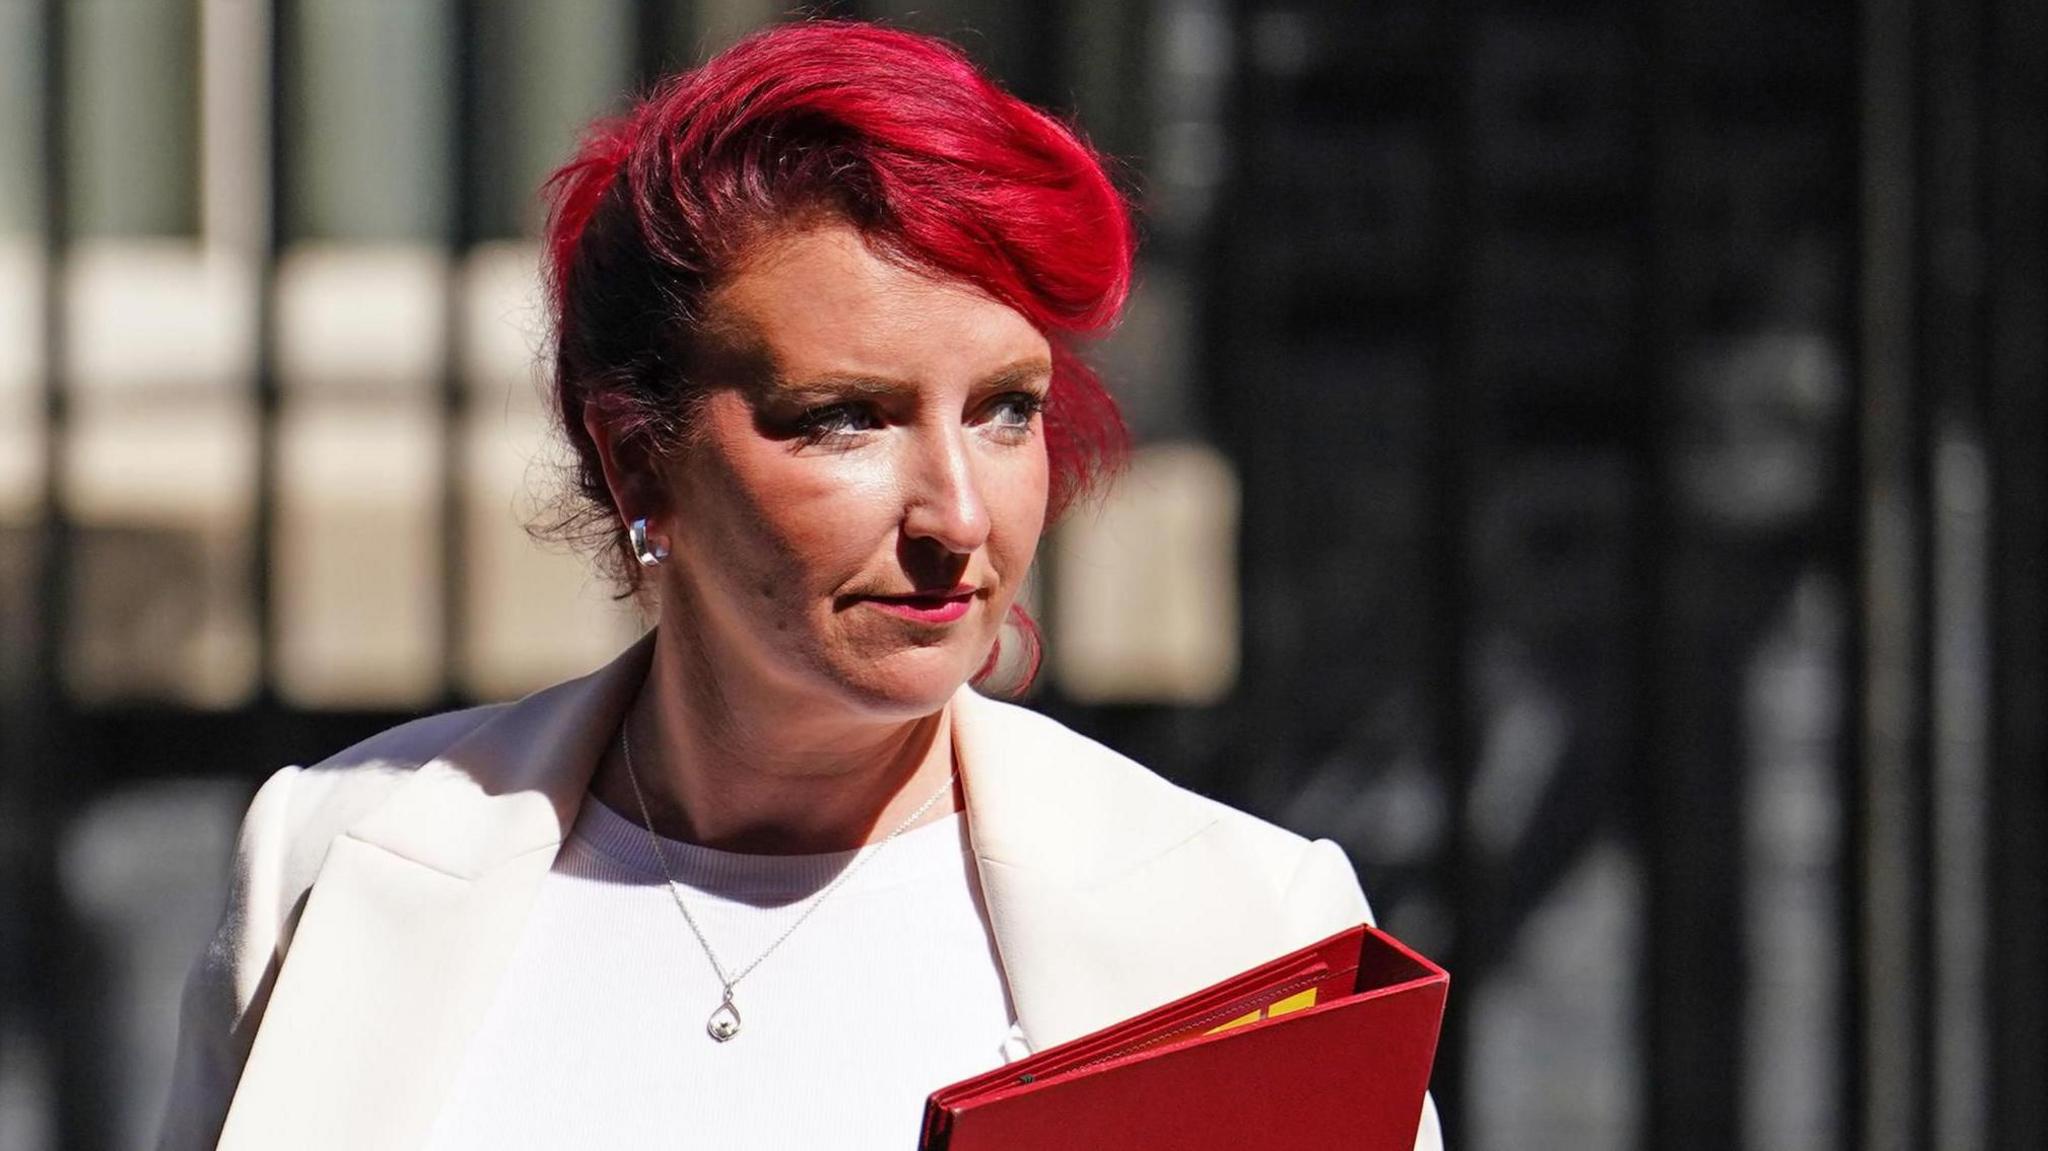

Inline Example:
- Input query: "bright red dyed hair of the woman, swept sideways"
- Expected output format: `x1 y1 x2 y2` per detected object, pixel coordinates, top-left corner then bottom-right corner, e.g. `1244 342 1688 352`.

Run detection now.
545 20 1135 618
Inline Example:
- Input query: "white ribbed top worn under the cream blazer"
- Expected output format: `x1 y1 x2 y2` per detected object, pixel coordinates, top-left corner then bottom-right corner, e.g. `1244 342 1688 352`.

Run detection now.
428 797 1022 1151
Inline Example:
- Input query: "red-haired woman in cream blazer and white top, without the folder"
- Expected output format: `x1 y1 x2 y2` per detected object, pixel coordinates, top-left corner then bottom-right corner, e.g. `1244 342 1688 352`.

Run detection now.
164 23 1436 1149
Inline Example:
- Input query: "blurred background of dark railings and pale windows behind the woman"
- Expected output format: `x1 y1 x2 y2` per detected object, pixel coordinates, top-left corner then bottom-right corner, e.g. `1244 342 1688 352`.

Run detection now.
0 0 2048 1151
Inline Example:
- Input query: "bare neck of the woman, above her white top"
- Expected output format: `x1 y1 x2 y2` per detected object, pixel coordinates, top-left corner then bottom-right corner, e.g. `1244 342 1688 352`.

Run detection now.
592 622 961 854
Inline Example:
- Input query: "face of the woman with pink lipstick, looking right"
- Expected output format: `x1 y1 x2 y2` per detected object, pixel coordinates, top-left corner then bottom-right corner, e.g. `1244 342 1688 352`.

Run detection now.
655 223 1053 717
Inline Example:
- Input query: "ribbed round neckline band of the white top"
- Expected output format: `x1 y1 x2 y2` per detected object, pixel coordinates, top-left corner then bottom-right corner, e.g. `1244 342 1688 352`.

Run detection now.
569 793 969 903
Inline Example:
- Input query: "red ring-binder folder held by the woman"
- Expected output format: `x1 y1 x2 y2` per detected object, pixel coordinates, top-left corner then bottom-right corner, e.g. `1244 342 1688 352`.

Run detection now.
920 924 1450 1151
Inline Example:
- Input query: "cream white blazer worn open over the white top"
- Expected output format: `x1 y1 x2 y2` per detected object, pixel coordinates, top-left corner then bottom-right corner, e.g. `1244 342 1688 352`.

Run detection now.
162 635 1442 1151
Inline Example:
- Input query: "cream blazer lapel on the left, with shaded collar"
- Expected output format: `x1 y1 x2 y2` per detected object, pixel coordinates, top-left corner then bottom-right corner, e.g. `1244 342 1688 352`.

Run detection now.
221 635 653 1149
